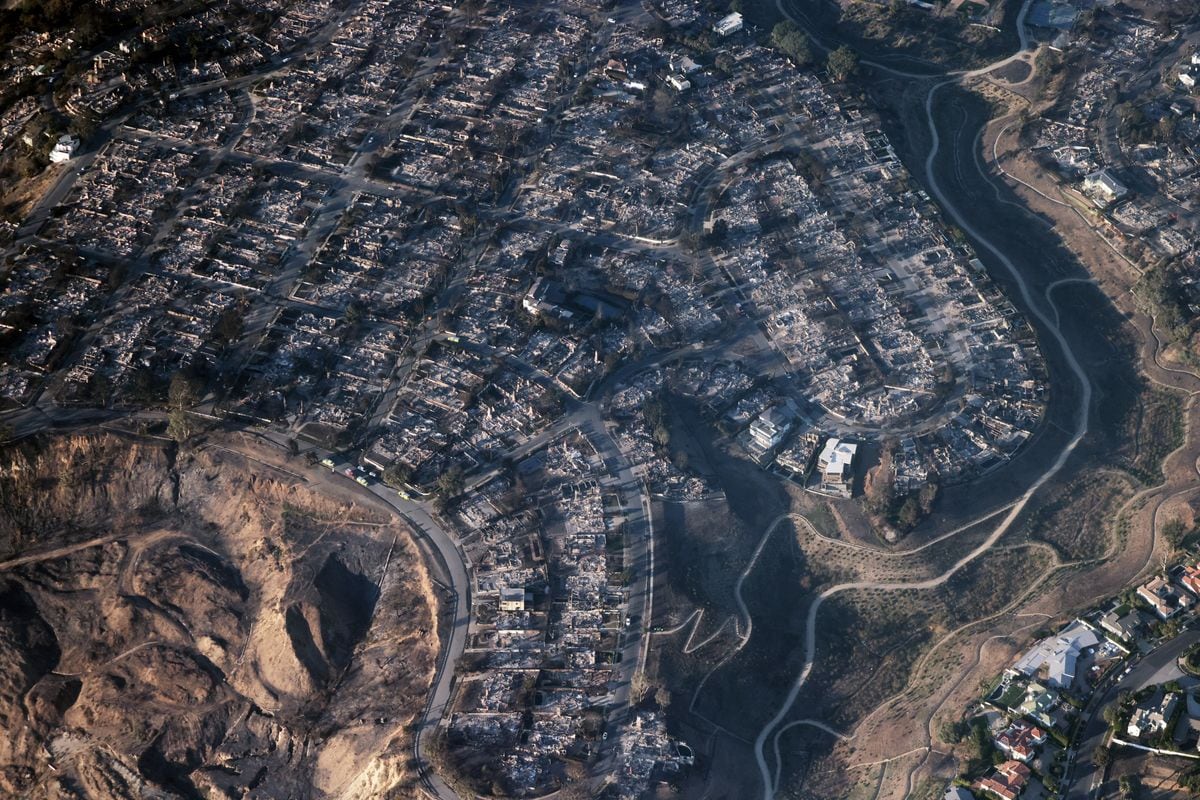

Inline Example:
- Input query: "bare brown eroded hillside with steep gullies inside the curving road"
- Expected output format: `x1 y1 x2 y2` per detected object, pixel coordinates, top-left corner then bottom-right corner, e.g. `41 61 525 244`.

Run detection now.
0 435 437 800
